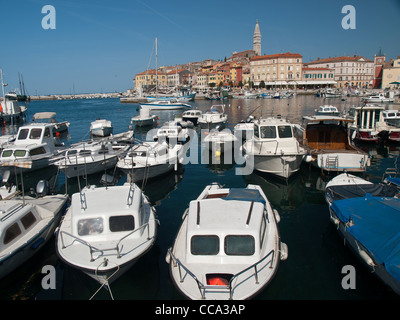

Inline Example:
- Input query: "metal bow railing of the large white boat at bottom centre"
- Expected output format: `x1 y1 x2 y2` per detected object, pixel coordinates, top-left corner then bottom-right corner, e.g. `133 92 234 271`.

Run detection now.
168 248 275 300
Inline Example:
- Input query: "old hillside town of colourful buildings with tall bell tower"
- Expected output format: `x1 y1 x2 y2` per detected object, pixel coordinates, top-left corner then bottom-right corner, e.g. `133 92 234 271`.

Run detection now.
132 20 400 93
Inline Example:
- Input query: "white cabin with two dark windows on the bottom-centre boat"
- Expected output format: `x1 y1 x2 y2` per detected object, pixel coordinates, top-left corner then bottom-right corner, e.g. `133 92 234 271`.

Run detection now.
186 188 269 271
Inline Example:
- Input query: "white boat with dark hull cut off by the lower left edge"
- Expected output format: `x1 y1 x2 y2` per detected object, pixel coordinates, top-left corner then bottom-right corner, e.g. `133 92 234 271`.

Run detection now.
0 182 68 278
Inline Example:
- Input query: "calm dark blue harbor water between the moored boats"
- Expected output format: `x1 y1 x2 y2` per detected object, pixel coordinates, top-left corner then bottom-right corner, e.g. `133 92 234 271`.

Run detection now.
0 95 400 300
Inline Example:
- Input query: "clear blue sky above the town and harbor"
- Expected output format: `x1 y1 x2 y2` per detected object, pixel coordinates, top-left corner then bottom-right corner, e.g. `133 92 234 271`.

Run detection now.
0 0 400 95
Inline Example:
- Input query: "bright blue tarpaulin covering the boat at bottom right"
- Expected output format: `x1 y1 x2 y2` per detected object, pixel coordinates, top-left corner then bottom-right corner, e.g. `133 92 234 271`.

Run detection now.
332 194 400 281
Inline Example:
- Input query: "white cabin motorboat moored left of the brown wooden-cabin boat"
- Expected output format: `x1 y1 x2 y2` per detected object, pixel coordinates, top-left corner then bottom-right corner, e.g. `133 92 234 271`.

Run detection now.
243 117 306 179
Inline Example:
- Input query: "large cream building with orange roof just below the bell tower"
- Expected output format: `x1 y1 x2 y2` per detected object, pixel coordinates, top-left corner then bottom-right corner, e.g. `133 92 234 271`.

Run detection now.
250 52 303 87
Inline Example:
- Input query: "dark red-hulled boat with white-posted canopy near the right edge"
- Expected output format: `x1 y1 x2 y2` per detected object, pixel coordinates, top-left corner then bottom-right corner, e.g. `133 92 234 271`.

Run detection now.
348 104 400 143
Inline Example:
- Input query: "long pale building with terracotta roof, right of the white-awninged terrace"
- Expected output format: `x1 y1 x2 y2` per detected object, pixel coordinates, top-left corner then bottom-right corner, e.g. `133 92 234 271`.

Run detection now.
304 55 374 88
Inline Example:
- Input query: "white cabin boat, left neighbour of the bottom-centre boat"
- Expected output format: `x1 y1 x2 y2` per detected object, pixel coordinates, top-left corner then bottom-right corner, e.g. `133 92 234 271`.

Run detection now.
56 183 158 286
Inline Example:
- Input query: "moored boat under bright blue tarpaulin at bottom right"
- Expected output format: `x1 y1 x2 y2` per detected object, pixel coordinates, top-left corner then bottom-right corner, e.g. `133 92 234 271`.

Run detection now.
330 194 400 295
